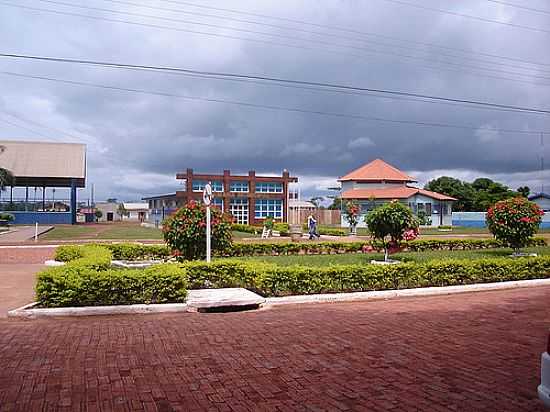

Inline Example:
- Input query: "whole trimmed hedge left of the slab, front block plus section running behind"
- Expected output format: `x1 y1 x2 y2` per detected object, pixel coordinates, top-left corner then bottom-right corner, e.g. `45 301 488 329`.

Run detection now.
40 244 187 307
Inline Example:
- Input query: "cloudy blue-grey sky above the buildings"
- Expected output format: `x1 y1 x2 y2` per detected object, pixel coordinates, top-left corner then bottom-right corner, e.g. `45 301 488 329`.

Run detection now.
0 0 550 200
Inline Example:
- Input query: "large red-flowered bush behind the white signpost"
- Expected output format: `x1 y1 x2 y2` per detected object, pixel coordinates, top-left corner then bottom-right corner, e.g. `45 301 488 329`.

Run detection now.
162 201 232 260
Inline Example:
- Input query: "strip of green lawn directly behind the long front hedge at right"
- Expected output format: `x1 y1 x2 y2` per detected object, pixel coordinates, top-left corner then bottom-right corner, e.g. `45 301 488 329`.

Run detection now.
240 246 550 266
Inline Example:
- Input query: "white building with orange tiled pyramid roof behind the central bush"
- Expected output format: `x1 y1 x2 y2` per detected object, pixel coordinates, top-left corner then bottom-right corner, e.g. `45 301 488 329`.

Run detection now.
338 159 456 227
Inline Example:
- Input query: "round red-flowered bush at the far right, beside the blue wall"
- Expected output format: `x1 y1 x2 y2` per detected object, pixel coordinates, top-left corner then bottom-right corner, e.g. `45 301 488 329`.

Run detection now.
486 197 544 252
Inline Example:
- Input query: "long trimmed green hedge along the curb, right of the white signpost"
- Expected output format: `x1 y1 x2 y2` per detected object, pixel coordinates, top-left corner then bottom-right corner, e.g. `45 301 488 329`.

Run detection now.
183 256 550 296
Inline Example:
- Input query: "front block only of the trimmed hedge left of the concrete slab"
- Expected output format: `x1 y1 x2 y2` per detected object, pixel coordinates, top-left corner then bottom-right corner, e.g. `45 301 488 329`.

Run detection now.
36 263 187 307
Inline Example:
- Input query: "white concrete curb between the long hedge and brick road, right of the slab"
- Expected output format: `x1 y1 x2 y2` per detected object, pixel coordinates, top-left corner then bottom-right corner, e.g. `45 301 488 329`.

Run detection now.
265 279 550 306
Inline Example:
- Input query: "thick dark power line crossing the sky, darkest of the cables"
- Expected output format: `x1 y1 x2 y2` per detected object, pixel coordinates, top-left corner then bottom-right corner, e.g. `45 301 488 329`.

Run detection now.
0 53 550 114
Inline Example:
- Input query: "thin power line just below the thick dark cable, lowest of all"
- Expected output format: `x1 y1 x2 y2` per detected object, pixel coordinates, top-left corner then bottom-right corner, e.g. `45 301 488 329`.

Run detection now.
0 71 548 135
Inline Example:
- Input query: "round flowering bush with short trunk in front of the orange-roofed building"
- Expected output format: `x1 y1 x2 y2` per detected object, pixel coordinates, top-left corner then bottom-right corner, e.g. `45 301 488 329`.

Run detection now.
366 201 419 261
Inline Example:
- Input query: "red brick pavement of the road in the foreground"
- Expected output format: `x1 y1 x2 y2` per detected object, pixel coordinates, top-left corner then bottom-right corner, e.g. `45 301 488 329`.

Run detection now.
0 287 550 412
